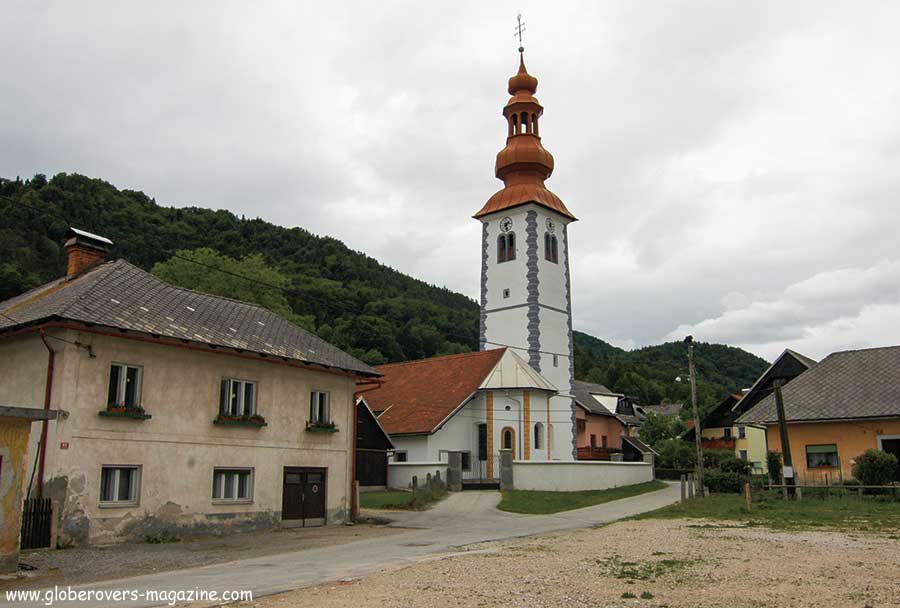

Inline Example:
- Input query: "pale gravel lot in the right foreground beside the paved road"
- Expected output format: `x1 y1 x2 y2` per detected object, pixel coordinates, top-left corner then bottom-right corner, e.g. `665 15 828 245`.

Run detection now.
244 520 900 608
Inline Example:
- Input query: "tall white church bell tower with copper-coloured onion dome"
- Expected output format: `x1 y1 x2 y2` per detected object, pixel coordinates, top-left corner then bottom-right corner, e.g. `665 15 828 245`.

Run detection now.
474 47 577 460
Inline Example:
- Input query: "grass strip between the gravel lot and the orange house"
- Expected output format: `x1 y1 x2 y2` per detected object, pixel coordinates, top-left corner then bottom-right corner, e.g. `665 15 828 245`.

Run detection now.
634 492 900 538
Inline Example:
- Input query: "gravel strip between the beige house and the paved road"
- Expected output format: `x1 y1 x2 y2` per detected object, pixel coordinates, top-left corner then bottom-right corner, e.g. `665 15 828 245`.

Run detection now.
0 524 400 589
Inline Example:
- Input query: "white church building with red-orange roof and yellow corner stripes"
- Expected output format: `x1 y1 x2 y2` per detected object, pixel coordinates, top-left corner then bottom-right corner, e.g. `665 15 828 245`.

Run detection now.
365 348 560 480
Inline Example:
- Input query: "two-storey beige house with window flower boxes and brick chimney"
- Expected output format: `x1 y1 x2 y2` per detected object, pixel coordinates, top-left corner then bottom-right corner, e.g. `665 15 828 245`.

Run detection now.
0 231 379 545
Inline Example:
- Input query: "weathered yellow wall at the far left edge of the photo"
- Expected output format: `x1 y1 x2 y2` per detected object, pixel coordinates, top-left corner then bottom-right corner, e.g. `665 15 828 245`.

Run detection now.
0 418 31 573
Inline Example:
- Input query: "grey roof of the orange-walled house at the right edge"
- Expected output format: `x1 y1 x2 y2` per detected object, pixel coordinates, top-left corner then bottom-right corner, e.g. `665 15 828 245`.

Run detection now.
738 346 900 424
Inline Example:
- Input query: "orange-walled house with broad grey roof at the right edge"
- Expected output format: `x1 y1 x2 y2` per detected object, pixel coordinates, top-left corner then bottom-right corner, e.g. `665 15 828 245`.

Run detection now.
738 346 900 483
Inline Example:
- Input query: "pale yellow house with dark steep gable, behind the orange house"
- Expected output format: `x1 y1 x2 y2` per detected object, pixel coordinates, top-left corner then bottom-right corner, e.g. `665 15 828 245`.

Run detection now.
689 349 816 474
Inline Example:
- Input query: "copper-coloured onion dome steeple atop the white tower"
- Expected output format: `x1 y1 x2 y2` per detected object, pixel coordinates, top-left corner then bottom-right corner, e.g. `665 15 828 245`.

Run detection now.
474 47 576 220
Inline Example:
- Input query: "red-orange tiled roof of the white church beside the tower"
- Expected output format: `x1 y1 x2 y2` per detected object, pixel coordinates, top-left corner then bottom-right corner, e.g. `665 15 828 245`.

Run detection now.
365 348 506 435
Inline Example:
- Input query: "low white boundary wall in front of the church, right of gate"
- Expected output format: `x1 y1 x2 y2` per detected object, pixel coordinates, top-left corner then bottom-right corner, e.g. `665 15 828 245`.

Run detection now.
513 460 653 492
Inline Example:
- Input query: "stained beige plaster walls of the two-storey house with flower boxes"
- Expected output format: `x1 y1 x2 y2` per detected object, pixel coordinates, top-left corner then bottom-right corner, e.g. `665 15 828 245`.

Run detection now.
0 330 355 543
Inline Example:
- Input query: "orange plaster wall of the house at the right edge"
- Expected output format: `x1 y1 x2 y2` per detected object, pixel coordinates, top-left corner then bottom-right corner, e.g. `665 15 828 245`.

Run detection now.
766 420 900 482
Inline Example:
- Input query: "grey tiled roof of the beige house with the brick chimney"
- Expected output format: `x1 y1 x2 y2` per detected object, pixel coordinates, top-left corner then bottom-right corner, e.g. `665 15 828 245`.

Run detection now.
0 260 380 376
